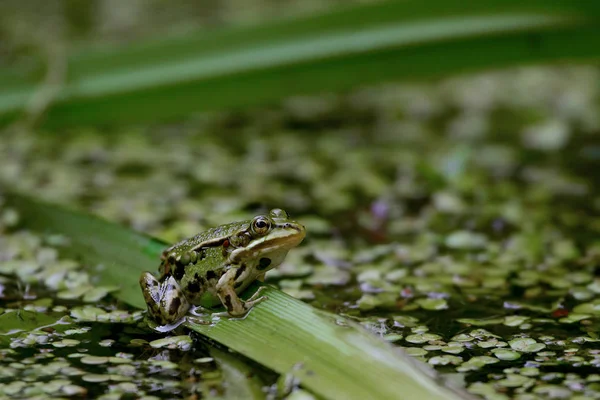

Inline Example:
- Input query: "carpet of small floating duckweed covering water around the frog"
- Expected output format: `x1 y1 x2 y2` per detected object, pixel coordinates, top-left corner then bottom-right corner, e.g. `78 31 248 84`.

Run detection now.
0 62 600 399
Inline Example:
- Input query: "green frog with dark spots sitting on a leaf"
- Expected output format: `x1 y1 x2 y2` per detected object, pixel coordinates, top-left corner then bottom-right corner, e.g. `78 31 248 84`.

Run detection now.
139 208 306 332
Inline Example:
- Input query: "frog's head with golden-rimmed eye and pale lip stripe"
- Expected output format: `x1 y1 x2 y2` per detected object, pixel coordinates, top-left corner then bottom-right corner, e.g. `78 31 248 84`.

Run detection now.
229 208 306 271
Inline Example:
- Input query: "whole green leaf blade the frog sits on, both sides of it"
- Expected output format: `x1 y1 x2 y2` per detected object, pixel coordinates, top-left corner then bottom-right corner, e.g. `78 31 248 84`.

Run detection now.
5 194 470 400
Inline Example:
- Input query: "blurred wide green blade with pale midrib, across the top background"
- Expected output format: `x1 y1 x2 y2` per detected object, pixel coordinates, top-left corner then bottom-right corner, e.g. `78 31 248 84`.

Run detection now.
0 0 600 127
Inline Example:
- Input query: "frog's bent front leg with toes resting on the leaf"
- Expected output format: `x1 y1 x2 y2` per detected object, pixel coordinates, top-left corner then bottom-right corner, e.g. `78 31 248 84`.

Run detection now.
214 267 267 317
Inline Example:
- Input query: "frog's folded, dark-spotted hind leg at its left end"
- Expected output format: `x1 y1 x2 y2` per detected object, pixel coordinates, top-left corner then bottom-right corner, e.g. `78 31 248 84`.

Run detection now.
140 272 190 325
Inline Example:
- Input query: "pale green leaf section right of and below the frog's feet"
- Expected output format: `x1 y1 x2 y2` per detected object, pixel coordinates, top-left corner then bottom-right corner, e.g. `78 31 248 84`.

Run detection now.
188 288 462 400
